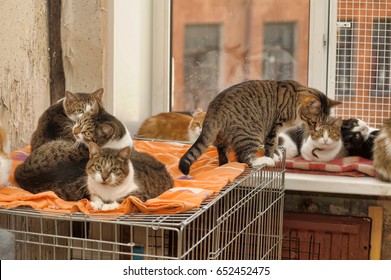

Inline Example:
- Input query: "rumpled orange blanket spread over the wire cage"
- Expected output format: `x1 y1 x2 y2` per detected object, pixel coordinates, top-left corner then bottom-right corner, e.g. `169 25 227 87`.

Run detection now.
0 141 246 216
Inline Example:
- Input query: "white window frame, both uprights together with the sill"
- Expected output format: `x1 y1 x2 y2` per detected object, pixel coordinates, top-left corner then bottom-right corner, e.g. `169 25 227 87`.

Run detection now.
106 0 391 196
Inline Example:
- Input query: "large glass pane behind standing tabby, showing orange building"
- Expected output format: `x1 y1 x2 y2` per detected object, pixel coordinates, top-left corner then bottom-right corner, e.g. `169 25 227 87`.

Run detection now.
171 0 310 111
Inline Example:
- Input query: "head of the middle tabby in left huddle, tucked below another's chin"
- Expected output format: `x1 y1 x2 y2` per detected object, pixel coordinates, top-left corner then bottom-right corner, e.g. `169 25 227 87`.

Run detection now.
72 114 114 146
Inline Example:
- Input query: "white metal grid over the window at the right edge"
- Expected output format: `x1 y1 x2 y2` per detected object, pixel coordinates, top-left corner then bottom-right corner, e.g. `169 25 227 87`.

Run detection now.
335 0 391 128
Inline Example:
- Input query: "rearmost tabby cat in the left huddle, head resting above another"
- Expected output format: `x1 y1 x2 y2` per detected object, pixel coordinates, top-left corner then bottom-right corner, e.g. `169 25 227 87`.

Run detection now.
30 89 103 151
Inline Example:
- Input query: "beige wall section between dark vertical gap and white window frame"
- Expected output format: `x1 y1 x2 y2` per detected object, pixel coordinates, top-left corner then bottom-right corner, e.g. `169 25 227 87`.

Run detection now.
61 0 107 94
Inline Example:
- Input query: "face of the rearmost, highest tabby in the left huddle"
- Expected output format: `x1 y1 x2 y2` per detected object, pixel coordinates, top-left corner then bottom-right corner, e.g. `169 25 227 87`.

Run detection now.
64 89 103 121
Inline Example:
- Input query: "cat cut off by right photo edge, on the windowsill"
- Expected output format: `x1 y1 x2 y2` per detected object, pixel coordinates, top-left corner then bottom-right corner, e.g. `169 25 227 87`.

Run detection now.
373 119 391 182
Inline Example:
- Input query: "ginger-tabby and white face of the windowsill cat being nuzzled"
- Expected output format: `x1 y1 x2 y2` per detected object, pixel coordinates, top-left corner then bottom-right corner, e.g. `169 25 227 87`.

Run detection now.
311 117 342 149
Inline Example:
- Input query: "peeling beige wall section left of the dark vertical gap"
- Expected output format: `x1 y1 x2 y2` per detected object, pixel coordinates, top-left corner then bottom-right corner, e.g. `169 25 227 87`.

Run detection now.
0 0 49 149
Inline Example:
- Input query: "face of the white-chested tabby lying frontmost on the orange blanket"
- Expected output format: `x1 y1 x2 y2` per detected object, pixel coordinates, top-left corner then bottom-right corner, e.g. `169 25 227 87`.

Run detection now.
86 142 131 187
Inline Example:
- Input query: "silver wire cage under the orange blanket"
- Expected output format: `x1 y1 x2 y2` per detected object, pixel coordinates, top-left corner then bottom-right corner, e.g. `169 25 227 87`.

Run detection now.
0 148 285 260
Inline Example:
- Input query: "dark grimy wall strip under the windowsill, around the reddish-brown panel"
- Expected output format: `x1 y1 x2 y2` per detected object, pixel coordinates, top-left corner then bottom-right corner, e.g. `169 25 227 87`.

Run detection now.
285 191 391 260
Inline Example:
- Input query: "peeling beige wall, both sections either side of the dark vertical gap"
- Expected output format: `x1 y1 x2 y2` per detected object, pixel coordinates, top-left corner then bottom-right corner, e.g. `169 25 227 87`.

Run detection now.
0 0 107 150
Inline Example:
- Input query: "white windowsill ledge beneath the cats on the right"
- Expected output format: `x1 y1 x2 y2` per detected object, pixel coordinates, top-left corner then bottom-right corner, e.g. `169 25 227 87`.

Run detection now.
285 172 391 196
